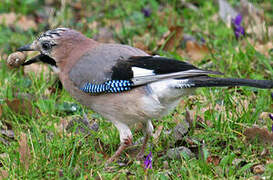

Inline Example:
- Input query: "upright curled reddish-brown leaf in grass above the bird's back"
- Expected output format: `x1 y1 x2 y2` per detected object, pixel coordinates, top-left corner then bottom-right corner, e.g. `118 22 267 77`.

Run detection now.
163 26 183 51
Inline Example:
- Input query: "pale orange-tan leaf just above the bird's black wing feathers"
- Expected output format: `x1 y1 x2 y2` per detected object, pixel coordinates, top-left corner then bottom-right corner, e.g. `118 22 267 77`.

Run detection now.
186 41 210 61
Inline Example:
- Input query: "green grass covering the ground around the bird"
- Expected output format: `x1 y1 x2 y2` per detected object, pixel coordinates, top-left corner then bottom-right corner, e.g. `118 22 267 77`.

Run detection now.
0 0 273 179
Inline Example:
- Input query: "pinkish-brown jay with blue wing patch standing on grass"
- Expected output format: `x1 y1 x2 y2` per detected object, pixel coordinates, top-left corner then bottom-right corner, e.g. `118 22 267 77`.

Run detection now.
17 28 273 164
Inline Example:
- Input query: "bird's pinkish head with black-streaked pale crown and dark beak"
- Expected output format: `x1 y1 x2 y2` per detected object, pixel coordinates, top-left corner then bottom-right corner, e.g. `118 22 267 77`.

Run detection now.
17 28 91 65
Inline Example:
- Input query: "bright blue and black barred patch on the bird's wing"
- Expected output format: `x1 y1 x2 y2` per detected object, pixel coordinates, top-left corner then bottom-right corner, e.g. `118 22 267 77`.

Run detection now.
81 80 134 94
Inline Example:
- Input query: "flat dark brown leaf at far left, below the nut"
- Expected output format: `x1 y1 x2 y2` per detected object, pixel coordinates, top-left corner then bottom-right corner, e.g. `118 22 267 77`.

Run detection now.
6 98 35 116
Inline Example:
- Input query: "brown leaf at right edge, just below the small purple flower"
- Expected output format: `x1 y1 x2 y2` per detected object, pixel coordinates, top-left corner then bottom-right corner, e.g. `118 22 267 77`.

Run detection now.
244 127 273 144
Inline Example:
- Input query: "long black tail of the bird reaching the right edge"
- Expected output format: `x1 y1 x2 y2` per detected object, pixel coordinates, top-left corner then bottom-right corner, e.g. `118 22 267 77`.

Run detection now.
189 76 273 89
